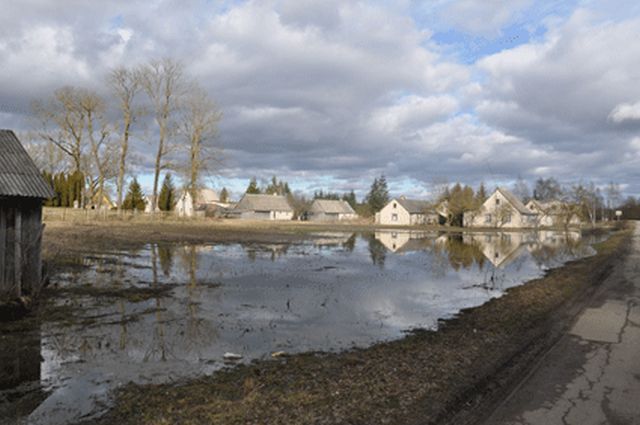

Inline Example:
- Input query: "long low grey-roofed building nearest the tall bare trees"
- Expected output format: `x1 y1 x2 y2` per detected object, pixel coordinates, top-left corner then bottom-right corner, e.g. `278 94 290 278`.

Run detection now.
229 194 293 220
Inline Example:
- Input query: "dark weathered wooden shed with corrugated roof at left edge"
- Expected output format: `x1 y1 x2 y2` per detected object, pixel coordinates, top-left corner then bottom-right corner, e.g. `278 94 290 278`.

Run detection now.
0 130 54 299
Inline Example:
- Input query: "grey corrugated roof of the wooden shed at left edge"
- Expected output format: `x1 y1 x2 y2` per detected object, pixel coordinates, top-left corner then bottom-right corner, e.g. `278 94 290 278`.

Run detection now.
0 130 54 199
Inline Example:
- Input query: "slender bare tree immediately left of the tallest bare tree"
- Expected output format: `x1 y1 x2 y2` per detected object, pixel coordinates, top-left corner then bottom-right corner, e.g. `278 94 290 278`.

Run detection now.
108 67 140 210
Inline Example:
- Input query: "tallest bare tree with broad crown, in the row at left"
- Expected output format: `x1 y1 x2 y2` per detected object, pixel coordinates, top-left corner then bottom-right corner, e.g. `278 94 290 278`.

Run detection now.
139 58 184 211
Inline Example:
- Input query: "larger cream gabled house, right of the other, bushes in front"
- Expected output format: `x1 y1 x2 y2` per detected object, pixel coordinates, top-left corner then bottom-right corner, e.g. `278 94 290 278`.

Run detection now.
463 187 538 228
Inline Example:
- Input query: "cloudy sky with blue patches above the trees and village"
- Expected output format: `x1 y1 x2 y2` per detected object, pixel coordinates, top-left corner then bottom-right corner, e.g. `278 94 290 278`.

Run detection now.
0 0 640 197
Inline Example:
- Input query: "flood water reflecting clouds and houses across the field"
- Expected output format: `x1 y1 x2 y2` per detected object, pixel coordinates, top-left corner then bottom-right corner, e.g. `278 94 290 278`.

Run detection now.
0 231 608 424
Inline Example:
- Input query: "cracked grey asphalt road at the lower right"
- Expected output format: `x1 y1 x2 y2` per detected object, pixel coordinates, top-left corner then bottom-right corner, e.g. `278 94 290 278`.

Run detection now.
484 224 640 425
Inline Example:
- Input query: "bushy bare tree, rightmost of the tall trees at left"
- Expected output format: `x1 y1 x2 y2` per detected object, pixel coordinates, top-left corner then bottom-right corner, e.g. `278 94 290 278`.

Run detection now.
180 87 222 199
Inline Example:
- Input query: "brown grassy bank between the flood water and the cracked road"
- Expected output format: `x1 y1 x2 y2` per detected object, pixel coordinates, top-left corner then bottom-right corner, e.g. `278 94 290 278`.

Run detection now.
84 225 630 425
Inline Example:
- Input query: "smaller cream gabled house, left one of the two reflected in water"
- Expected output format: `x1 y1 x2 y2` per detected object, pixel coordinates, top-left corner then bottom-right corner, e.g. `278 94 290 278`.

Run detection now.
375 196 440 226
